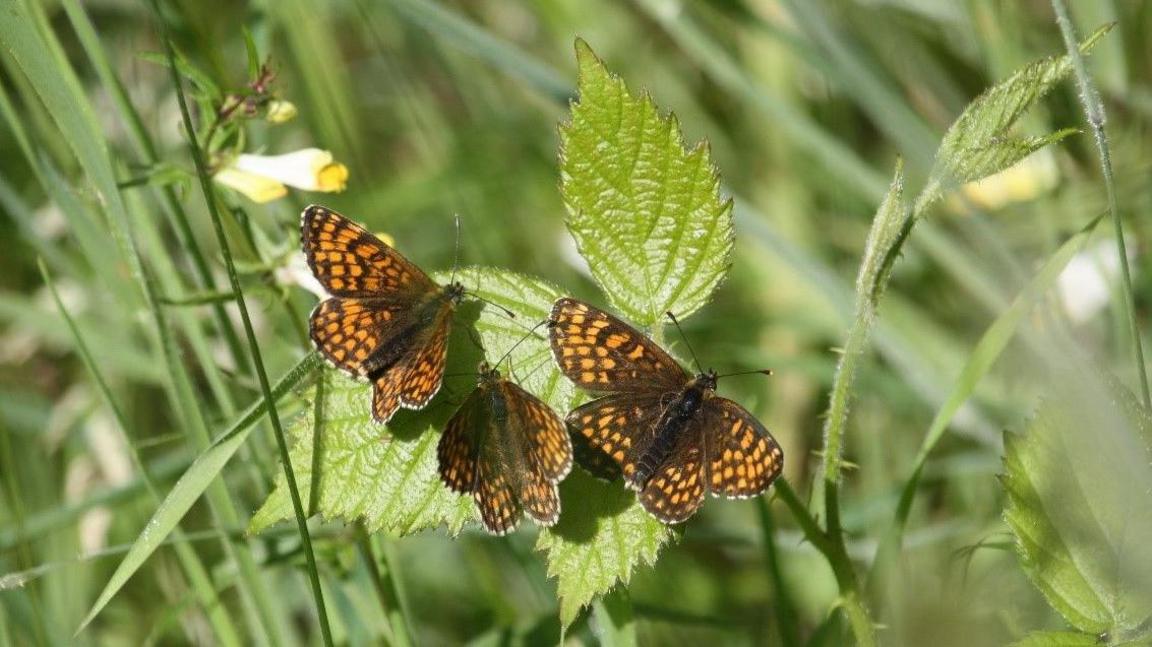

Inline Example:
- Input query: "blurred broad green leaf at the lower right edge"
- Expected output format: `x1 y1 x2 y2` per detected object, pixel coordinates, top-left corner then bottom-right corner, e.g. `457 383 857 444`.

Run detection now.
1002 366 1152 638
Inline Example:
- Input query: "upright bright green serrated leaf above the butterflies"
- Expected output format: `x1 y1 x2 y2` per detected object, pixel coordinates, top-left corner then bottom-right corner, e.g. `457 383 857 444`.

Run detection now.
560 40 733 326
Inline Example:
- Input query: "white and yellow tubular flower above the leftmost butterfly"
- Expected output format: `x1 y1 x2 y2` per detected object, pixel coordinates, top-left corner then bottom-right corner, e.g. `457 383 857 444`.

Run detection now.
214 149 348 203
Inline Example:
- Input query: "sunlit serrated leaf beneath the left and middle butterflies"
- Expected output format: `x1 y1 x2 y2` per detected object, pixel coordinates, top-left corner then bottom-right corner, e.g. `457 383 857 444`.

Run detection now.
249 268 573 535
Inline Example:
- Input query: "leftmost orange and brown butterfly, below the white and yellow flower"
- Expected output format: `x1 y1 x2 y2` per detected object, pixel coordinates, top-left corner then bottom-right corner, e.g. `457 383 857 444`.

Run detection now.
301 205 464 423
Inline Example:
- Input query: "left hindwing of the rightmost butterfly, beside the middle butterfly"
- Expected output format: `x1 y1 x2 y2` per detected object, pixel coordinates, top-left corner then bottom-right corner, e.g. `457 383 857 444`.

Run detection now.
566 394 667 487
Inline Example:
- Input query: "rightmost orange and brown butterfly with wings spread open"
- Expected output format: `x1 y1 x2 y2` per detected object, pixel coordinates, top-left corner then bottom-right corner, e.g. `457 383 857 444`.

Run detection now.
548 297 783 524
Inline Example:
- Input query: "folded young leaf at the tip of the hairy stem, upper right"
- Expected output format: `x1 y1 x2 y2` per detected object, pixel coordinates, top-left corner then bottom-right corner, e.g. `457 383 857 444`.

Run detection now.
917 25 1112 206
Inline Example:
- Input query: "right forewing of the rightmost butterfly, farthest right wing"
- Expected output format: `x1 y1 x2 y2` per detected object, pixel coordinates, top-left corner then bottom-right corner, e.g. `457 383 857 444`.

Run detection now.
694 396 785 498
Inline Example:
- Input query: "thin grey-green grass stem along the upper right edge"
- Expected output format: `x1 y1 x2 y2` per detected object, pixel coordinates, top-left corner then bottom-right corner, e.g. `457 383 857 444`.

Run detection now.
1052 0 1152 409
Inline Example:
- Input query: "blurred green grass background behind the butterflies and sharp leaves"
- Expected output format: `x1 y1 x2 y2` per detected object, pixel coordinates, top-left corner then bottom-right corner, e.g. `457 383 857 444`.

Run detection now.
0 0 1152 645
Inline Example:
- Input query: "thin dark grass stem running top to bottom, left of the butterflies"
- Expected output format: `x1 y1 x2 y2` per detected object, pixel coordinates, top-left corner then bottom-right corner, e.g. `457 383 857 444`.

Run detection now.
151 0 332 647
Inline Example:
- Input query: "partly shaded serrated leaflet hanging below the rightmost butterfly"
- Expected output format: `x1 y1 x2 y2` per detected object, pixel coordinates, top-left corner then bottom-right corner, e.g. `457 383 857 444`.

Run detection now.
536 469 672 626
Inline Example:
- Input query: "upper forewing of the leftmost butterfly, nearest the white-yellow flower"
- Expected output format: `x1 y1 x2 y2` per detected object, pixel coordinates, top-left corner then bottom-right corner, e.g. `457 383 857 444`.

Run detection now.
301 205 438 303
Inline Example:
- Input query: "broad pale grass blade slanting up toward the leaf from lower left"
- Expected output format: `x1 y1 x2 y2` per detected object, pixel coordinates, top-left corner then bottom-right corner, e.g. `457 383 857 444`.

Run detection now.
79 353 319 630
